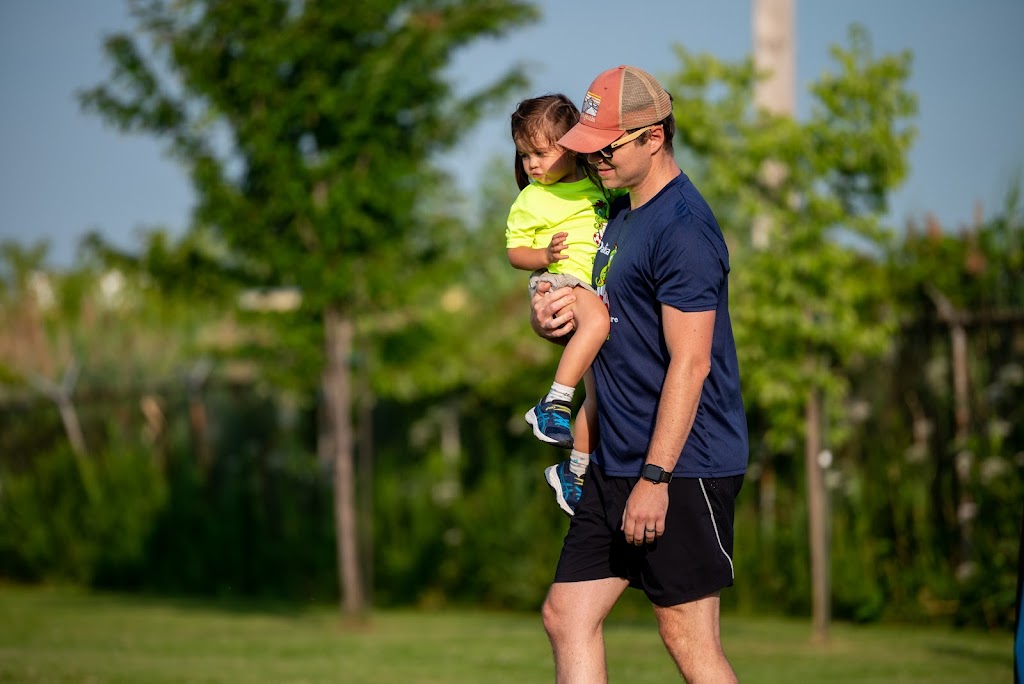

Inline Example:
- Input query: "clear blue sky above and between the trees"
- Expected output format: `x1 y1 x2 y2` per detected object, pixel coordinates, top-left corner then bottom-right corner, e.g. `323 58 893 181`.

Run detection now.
0 0 1024 265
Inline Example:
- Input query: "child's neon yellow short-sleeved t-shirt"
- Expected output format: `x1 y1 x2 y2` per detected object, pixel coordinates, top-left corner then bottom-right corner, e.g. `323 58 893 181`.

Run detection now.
505 178 608 285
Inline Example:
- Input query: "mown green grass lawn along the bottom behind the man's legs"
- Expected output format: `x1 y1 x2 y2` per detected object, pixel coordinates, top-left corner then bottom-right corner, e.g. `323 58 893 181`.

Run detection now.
0 587 1013 684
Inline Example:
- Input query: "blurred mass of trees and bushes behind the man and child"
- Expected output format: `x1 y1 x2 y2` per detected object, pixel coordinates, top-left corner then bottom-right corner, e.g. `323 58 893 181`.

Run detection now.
0 0 1024 643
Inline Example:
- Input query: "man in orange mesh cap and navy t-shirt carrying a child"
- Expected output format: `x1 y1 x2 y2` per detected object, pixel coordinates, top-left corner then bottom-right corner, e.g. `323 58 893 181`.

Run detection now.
531 67 748 684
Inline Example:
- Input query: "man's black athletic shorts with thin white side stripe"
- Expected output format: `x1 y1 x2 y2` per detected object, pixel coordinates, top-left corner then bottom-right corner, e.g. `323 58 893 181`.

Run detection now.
555 463 743 607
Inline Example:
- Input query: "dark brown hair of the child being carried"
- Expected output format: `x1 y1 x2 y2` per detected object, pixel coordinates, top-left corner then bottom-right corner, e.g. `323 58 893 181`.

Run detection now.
512 93 604 193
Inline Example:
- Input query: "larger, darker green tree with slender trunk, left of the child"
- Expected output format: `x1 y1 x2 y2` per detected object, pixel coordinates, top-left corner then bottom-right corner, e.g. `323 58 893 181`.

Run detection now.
83 0 537 613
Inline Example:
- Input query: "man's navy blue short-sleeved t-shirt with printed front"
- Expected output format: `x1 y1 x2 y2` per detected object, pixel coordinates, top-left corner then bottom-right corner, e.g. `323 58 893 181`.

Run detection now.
594 173 748 477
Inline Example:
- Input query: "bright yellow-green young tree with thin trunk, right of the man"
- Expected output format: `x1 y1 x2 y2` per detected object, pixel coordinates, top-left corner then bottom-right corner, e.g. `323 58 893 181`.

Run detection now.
667 27 916 638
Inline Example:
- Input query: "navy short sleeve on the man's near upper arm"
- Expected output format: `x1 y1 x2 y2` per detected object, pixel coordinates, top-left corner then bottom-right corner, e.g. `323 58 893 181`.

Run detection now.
651 216 729 311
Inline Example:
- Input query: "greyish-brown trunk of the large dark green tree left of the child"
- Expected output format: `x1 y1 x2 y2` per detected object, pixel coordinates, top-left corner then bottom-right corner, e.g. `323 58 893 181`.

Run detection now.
324 306 367 615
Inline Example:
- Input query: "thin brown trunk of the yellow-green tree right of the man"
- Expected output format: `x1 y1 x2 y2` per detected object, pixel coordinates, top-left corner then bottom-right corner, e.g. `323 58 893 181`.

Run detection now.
804 388 830 643
